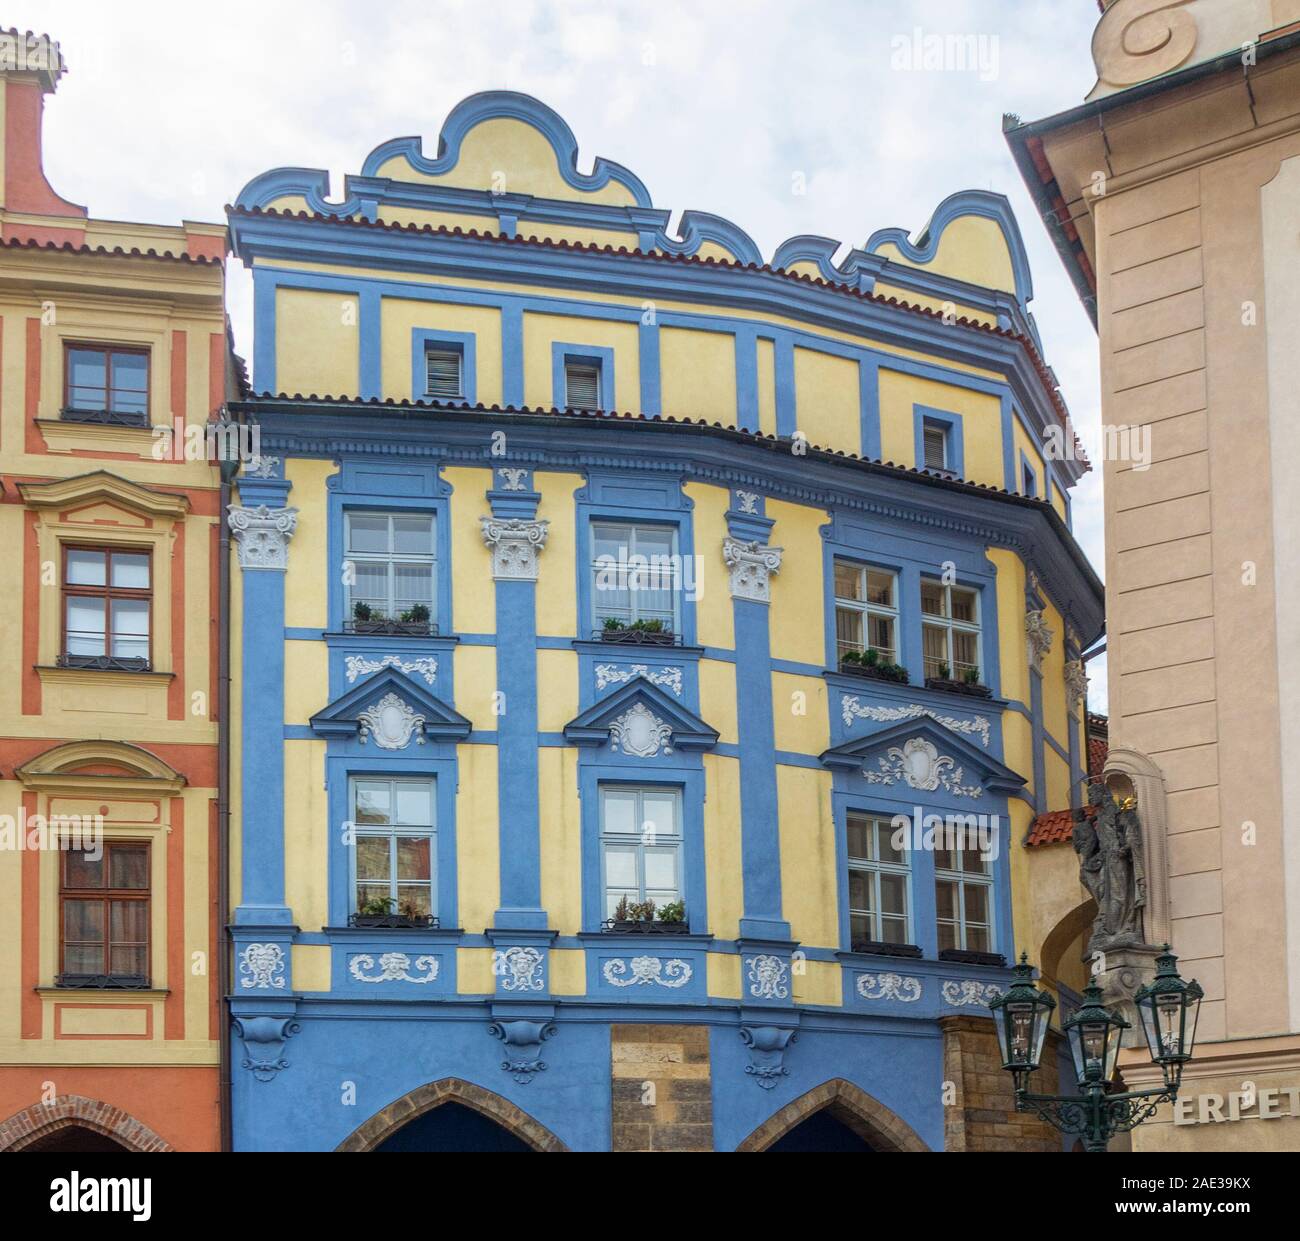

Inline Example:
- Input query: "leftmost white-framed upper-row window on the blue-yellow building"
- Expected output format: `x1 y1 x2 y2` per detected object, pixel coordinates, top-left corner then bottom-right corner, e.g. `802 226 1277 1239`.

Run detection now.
346 512 437 621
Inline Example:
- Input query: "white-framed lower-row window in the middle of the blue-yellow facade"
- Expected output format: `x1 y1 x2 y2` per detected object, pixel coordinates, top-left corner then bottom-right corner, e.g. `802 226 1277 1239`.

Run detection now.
601 785 683 917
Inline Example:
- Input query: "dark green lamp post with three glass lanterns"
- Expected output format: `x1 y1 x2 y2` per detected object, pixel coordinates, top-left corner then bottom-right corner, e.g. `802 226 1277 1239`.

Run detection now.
989 943 1204 1151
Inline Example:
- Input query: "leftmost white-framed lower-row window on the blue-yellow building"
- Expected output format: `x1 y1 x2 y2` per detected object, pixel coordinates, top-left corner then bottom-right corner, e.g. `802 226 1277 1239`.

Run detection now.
350 776 438 920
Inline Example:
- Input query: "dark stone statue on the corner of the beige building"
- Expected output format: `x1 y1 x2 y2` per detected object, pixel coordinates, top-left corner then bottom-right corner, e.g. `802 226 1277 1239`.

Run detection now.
1073 784 1147 954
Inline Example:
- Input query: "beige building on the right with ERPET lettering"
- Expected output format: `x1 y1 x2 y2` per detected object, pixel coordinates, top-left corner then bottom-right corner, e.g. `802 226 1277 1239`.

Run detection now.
1006 0 1300 1150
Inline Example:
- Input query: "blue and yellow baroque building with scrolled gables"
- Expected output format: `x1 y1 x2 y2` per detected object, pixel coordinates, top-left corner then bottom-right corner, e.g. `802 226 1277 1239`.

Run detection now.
220 92 1102 1150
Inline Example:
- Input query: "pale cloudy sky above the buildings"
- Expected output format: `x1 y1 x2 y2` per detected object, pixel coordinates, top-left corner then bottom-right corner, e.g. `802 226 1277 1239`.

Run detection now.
5 0 1105 710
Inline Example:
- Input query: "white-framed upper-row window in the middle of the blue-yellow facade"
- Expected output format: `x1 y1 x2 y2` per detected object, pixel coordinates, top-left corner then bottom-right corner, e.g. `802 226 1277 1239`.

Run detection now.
592 521 680 633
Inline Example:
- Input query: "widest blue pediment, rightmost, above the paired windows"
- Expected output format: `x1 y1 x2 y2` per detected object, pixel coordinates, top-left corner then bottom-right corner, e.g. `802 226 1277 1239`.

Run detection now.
820 716 1024 795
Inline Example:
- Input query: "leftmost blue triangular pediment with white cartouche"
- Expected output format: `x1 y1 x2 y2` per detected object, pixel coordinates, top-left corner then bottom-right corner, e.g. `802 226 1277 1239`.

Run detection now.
311 668 473 750
